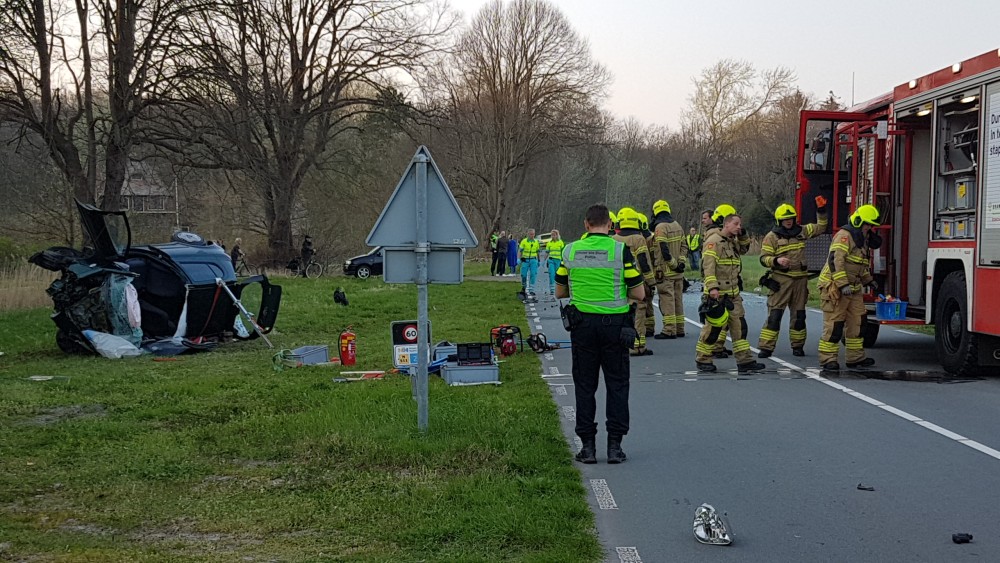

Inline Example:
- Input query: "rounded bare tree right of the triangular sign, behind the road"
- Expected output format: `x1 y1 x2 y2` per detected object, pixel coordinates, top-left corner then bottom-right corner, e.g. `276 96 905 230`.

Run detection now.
433 0 610 237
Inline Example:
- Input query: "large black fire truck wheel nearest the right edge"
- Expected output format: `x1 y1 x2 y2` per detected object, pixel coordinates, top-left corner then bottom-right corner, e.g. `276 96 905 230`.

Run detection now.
934 272 978 375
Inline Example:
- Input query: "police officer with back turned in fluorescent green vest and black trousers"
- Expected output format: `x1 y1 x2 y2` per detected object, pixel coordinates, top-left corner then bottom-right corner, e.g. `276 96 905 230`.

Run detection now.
556 204 645 463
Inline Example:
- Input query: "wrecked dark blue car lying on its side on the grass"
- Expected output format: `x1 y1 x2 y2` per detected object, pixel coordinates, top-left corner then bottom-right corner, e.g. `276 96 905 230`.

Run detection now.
28 201 281 353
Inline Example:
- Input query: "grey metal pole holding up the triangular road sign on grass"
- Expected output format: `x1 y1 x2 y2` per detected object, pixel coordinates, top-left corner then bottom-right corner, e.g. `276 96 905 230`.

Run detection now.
415 154 430 431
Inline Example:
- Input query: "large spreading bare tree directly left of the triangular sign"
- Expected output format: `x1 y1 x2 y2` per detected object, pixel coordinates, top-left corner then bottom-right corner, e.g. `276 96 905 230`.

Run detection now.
156 0 452 257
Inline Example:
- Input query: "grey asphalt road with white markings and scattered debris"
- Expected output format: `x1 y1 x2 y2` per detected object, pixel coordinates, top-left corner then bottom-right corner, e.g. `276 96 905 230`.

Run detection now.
526 278 1000 562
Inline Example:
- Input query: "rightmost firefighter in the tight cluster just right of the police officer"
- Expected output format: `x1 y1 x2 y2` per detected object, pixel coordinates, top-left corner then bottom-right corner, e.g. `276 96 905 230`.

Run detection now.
651 199 687 340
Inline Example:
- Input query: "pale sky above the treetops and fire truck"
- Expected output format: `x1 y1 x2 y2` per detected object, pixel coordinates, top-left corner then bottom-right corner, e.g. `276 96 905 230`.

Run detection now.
449 0 1000 128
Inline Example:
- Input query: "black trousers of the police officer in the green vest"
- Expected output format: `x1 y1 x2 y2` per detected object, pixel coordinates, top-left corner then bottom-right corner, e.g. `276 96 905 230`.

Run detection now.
570 313 629 440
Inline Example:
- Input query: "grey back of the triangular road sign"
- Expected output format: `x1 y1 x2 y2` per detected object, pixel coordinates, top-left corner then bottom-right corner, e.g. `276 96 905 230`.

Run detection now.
365 146 479 248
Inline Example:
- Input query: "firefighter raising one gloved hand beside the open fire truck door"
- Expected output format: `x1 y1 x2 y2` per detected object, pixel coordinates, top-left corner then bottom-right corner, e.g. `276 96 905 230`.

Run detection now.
757 196 826 358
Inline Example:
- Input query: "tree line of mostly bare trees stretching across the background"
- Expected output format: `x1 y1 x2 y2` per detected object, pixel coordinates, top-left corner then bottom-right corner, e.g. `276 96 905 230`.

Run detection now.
0 0 840 259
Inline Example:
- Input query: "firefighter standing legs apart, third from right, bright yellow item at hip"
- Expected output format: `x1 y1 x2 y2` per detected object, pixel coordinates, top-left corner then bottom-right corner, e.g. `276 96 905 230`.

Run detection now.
695 213 765 373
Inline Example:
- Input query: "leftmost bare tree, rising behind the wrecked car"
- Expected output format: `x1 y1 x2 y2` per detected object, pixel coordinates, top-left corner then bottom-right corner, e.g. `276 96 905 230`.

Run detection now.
0 0 203 209
